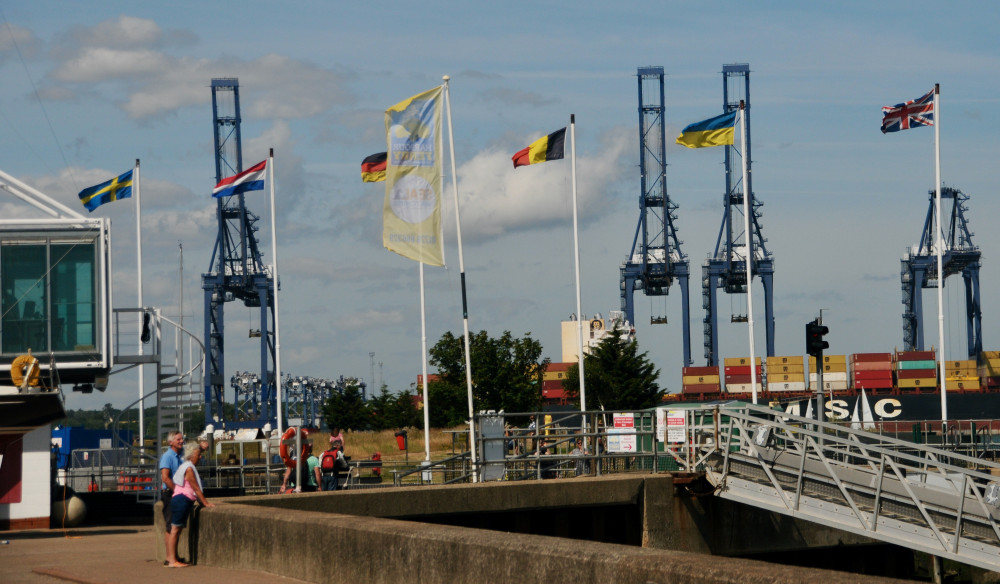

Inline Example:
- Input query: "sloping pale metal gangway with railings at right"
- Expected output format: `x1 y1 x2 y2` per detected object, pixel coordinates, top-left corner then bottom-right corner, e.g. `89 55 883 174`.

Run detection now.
674 402 1000 571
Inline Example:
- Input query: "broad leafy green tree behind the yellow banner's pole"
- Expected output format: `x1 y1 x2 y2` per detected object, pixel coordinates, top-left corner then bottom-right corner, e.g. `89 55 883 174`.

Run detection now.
428 331 549 418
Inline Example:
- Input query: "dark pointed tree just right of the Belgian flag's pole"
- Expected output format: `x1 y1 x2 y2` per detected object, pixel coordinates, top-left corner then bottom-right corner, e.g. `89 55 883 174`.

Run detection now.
563 329 666 410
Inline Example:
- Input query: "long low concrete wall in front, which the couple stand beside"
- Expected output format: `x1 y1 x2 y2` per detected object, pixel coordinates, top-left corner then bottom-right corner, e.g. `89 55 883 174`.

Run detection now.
191 494 912 584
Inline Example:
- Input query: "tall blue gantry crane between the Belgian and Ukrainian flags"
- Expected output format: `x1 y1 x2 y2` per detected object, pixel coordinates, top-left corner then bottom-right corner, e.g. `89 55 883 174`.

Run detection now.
620 67 691 367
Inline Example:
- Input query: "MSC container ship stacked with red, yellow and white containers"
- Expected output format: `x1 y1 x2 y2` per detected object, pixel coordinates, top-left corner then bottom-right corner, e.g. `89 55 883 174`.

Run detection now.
667 350 1000 431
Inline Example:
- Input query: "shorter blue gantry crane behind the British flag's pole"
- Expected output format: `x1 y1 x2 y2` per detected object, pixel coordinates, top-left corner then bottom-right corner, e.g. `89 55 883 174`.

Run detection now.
900 187 983 358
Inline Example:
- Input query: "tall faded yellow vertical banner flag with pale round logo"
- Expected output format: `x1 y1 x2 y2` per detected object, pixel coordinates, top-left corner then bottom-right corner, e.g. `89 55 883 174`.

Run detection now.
382 87 444 266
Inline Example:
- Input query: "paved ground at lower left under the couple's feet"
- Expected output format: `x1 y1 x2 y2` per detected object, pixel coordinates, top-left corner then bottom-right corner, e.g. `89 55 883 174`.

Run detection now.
0 525 303 584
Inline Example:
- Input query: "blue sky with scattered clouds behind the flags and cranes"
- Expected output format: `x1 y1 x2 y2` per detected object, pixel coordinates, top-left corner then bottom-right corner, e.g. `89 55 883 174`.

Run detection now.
0 1 1000 408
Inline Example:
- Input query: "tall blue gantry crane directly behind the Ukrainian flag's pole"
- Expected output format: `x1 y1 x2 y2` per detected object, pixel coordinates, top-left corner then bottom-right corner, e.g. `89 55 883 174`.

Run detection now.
702 63 774 366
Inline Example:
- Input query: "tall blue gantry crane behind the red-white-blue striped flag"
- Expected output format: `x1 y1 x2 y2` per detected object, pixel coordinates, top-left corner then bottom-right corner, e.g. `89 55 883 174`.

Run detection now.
202 78 277 429
